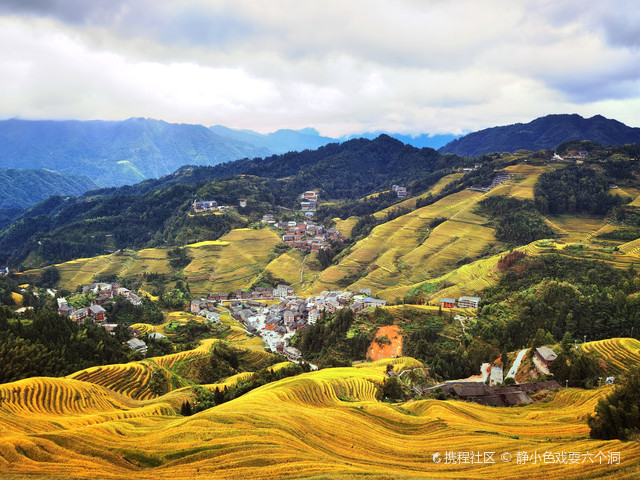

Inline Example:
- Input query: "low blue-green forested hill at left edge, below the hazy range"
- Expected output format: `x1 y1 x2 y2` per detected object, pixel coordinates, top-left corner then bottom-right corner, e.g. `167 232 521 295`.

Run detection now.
0 168 99 210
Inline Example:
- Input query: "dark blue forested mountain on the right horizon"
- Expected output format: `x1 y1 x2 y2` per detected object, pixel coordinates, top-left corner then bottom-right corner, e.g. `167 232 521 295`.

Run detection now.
440 114 640 157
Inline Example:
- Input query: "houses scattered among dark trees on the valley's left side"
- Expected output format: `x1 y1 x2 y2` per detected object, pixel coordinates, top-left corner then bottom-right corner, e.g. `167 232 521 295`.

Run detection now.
58 283 152 355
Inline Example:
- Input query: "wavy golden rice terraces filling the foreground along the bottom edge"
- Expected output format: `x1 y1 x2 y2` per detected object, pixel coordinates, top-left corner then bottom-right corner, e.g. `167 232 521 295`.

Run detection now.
0 359 640 479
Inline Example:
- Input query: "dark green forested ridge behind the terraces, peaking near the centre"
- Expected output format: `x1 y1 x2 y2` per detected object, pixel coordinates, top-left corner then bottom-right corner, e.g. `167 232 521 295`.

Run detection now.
0 129 637 278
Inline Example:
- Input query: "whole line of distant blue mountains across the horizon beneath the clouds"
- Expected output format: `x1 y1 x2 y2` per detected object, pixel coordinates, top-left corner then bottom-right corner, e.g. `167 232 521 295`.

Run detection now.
0 115 640 191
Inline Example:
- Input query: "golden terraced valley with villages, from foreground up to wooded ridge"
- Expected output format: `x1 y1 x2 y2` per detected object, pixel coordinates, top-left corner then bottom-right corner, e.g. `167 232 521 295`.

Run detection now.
0 132 640 479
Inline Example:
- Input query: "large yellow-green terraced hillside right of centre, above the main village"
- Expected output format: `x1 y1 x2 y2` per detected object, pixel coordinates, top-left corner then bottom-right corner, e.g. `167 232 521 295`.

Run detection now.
303 164 576 301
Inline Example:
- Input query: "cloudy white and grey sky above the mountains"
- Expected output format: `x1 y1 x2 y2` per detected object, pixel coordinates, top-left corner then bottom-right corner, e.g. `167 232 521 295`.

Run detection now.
0 0 640 136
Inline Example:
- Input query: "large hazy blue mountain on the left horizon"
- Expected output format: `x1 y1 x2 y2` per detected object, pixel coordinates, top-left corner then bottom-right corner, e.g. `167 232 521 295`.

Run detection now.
0 118 271 186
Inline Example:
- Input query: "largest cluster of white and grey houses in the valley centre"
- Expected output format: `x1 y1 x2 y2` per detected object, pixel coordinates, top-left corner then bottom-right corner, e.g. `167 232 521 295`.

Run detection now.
191 285 386 360
